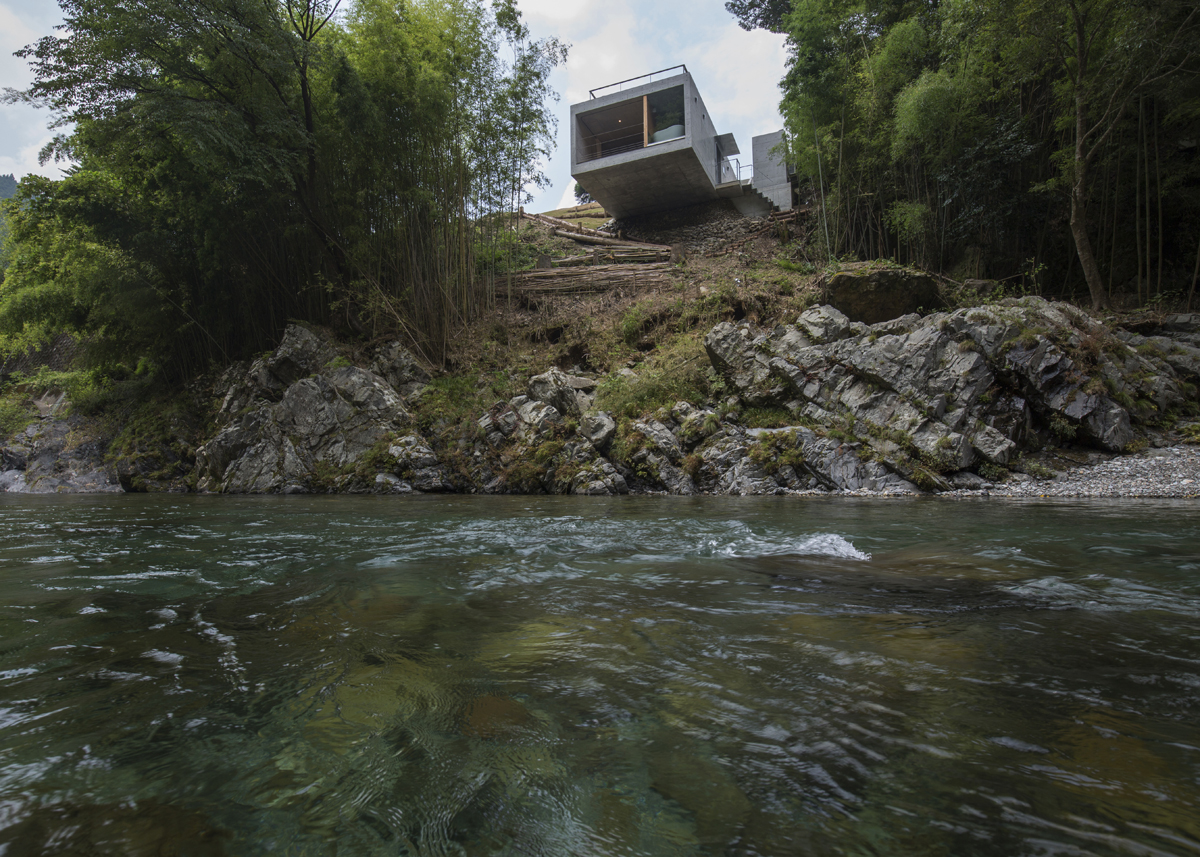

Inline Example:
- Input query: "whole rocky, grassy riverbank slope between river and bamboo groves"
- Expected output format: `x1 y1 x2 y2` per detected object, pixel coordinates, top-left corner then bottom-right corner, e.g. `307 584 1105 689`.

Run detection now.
0 204 1200 497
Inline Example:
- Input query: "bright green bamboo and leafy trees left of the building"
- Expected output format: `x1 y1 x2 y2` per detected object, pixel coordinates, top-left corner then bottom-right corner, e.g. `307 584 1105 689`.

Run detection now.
0 0 566 376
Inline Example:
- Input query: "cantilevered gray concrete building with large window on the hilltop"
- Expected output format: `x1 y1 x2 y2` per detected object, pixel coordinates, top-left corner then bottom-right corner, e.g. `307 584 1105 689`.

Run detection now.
571 66 793 217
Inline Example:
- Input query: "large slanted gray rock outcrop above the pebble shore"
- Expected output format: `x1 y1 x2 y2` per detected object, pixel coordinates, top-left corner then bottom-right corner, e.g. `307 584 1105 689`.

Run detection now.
704 298 1192 490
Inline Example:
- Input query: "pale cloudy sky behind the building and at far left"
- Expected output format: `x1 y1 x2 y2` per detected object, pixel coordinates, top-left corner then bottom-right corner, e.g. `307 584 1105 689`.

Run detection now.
0 0 786 211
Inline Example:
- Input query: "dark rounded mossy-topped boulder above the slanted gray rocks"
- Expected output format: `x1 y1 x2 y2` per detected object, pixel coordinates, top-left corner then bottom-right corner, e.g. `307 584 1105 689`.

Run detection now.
826 264 943 324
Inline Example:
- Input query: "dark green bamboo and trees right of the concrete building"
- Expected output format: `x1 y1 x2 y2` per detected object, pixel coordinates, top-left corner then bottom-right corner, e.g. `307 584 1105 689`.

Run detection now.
726 0 1200 307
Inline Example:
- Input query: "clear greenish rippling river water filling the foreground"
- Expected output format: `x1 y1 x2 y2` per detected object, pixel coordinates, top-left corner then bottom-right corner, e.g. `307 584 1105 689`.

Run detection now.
0 496 1200 857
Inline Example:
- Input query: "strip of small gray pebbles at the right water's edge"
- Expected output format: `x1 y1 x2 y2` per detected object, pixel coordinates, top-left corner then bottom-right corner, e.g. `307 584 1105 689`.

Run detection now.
943 445 1200 499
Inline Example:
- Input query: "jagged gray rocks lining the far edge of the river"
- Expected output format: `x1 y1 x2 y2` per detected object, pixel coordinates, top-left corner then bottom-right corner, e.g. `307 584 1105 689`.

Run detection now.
0 298 1200 495
